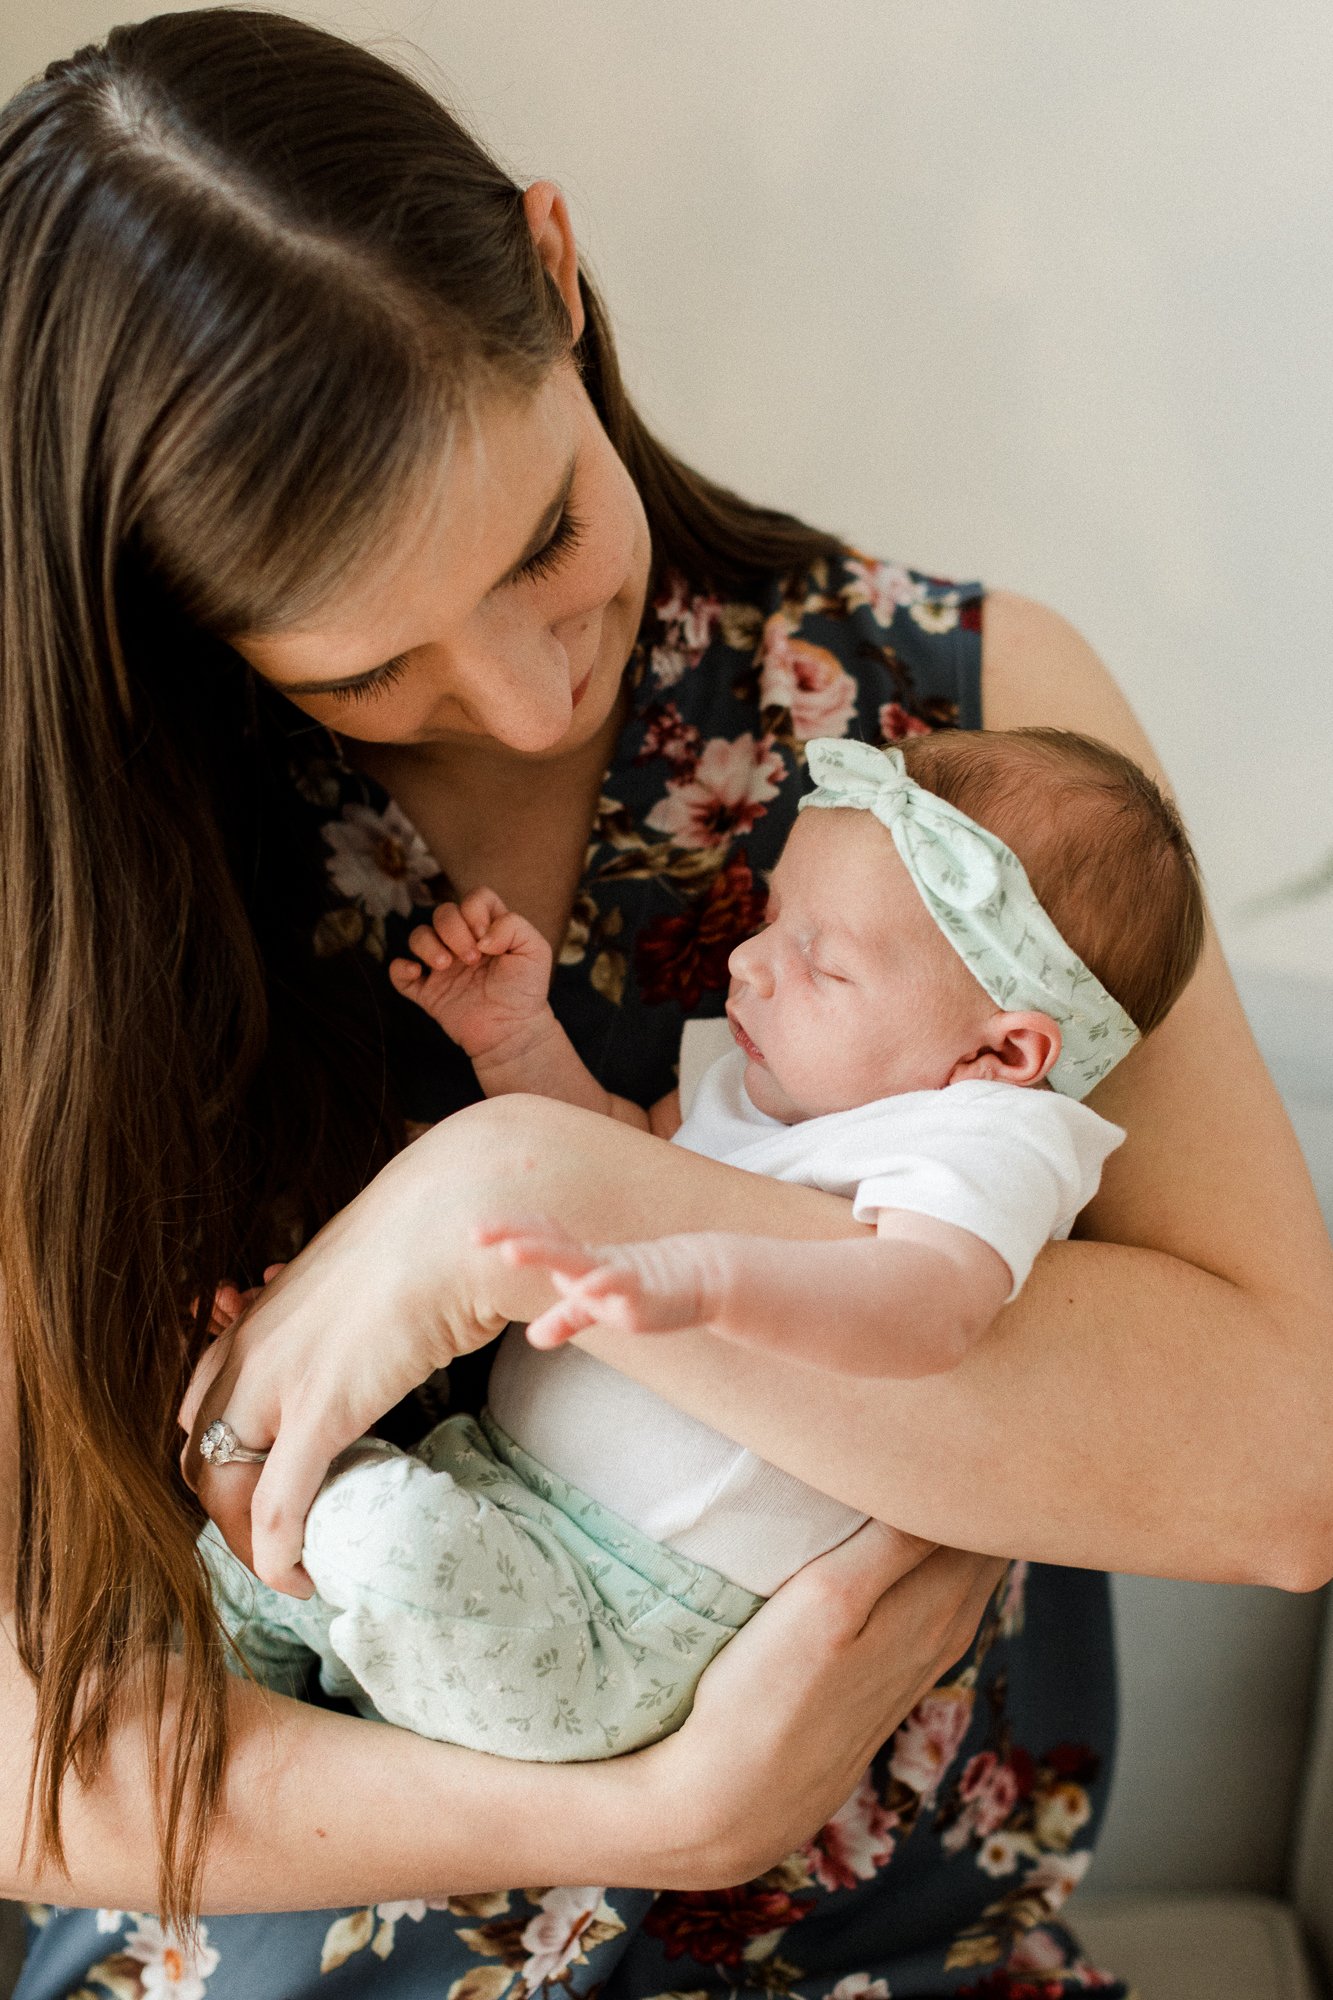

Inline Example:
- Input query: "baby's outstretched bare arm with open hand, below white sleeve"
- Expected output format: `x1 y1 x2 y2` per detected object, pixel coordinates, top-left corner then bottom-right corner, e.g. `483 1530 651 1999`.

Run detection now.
480 1210 1013 1376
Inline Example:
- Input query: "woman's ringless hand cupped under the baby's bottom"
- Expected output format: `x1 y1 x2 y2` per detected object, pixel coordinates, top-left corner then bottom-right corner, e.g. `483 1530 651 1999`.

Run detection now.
620 1522 1005 1890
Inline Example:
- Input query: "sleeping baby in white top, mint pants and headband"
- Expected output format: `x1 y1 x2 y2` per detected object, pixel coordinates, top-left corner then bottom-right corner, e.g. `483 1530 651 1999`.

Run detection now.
204 730 1203 1758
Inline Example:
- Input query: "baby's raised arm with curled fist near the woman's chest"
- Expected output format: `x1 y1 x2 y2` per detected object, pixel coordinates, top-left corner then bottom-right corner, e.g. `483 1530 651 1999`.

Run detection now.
388 888 679 1138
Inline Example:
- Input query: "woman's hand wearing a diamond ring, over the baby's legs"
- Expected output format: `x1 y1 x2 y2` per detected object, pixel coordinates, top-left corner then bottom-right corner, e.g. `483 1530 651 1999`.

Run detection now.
180 1106 524 1596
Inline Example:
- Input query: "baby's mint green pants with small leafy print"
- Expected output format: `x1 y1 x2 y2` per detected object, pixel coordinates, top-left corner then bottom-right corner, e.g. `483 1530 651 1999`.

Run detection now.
200 1412 763 1762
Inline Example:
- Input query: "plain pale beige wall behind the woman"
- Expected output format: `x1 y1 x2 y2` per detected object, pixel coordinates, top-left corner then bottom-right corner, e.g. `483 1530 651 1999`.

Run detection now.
0 0 1333 976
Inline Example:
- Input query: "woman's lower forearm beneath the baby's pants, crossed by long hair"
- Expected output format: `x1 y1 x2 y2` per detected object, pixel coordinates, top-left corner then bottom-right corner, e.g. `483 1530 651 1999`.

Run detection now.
0 1644 671 1914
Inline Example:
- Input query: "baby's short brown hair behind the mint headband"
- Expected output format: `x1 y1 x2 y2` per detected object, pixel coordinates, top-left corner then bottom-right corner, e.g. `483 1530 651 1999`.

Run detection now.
897 730 1205 1034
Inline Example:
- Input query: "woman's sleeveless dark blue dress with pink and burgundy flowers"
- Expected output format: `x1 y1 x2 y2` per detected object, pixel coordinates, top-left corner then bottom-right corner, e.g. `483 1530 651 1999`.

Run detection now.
16 552 1129 2000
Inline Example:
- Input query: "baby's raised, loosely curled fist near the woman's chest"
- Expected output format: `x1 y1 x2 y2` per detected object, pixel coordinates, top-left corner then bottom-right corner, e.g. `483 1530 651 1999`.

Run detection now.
388 888 550 1060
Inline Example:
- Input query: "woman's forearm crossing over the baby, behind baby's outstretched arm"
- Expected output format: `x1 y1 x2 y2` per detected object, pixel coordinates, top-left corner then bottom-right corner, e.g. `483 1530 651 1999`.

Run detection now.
464 1100 1333 1588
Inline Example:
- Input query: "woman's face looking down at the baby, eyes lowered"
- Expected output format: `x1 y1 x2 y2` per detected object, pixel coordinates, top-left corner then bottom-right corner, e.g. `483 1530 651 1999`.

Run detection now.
241 362 650 760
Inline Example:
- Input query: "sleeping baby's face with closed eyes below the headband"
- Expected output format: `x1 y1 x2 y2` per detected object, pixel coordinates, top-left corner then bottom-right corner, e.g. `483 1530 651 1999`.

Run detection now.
727 808 995 1124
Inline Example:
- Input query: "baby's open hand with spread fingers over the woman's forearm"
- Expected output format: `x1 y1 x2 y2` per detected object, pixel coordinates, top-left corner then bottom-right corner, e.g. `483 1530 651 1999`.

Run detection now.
474 1220 715 1348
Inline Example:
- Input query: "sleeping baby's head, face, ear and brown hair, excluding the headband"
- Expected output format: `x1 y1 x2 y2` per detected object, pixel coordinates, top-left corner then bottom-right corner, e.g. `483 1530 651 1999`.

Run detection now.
727 730 1203 1124
